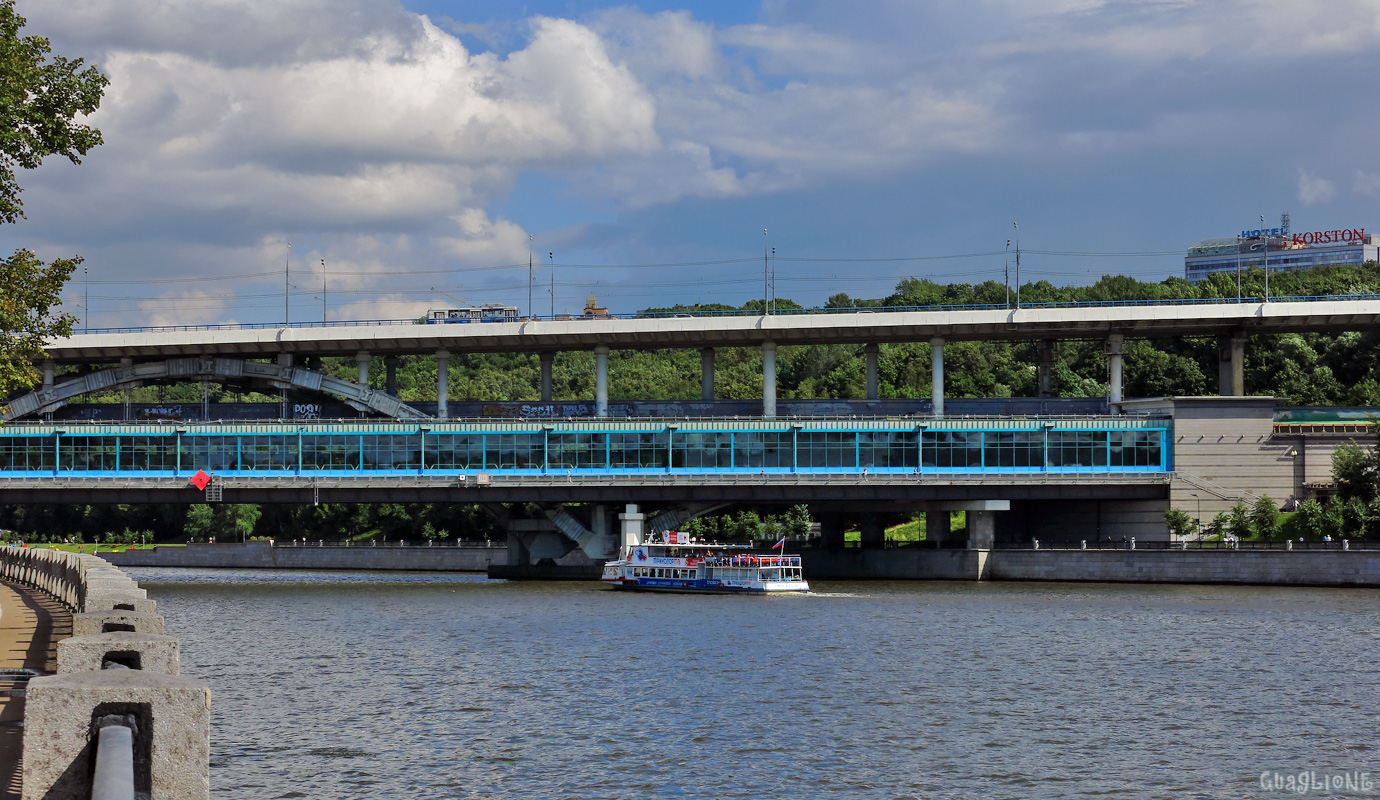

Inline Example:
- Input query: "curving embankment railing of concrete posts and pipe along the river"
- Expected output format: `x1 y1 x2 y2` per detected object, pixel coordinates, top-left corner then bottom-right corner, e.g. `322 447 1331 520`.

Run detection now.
0 546 211 800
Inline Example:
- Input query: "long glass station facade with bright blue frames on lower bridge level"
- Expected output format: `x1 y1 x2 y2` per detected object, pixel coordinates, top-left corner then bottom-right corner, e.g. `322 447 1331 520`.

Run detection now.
0 417 1172 477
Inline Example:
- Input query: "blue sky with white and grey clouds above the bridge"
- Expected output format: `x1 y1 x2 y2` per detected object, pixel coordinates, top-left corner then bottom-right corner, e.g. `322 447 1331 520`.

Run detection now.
8 0 1380 327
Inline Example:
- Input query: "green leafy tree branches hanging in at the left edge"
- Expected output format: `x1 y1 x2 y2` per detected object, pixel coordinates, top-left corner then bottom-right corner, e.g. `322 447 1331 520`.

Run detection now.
0 0 109 396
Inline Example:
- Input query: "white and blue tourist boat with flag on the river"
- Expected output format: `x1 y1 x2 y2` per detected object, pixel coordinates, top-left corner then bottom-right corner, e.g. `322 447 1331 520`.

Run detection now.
600 531 810 594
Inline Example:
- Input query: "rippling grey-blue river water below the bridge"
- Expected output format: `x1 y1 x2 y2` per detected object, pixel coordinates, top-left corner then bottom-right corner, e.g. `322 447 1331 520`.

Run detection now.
128 568 1380 800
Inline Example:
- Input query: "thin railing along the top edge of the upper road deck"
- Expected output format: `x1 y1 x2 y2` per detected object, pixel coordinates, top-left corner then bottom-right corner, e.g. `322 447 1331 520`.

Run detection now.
73 294 1380 334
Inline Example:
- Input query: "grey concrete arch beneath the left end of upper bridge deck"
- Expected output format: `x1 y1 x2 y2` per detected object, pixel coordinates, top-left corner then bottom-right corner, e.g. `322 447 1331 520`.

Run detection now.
0 359 429 422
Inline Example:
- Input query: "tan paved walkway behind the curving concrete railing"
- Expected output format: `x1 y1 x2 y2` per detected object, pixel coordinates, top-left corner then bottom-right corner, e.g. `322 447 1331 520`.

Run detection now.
0 581 72 800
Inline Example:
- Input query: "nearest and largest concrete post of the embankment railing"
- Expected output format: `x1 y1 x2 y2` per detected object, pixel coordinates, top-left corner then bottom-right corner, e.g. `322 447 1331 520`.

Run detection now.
22 669 211 800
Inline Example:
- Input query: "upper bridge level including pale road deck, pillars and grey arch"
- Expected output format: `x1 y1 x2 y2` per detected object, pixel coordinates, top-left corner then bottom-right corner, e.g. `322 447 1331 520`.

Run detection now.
4 295 1380 419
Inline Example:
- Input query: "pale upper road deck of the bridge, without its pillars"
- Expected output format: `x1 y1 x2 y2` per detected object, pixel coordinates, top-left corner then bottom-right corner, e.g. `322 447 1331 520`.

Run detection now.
37 295 1380 363
